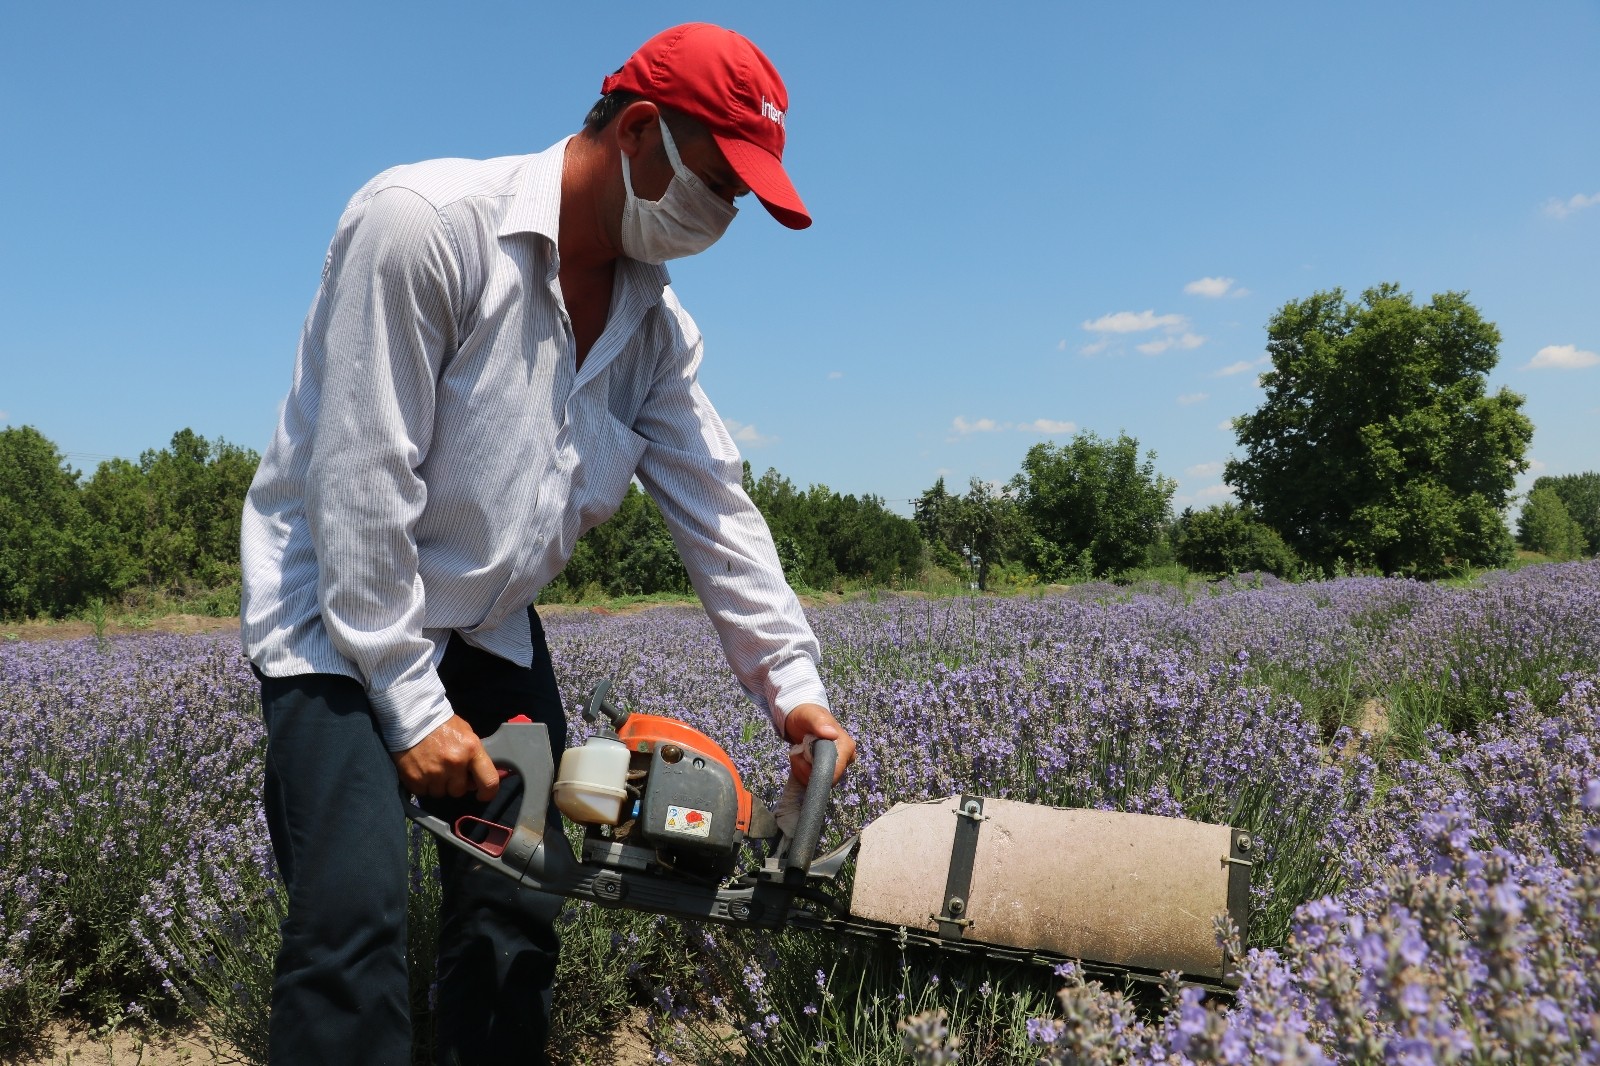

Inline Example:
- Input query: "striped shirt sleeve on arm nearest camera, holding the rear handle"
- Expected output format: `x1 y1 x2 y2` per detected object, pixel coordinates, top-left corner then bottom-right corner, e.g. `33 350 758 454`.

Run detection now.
306 187 461 751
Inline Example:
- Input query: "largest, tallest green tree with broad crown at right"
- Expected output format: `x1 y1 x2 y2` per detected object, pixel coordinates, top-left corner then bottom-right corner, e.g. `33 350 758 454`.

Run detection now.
1224 285 1533 578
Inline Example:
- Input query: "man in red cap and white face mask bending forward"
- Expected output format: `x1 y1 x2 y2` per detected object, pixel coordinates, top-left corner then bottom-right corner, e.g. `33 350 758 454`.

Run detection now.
242 24 854 1066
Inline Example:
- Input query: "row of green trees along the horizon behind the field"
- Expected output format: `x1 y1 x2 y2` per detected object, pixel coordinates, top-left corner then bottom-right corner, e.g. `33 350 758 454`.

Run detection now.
0 285 1600 619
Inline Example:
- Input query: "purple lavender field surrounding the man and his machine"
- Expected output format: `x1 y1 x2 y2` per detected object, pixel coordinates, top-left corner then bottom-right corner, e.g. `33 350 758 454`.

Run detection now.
0 562 1600 1064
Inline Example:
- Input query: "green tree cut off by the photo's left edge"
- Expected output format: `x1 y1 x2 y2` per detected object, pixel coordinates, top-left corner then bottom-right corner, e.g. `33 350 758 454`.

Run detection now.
0 426 90 618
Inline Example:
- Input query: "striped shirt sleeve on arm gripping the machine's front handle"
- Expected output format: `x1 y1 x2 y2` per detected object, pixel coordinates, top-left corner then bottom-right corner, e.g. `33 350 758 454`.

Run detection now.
634 335 827 735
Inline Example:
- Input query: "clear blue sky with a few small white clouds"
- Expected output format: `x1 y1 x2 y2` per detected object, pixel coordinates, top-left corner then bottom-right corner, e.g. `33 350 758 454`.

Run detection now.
0 0 1600 511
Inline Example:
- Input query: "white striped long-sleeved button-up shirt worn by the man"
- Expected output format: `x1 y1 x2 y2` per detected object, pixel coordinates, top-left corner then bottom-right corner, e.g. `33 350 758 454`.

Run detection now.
242 141 826 751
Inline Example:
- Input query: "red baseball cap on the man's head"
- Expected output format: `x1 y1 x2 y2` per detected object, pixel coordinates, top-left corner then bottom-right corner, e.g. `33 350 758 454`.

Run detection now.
600 22 811 229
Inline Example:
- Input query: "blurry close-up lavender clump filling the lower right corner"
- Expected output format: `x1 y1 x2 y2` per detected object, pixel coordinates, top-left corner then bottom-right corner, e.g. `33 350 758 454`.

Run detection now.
1017 679 1600 1064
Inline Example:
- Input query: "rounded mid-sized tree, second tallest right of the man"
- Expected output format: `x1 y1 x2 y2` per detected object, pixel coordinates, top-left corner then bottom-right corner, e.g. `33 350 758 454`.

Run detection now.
1011 431 1178 581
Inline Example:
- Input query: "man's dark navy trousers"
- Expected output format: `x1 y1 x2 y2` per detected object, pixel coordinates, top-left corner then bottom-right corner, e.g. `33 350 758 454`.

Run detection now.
258 608 566 1066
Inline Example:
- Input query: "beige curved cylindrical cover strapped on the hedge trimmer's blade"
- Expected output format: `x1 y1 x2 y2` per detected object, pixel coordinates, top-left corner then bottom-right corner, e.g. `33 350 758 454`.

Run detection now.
850 795 1248 978
